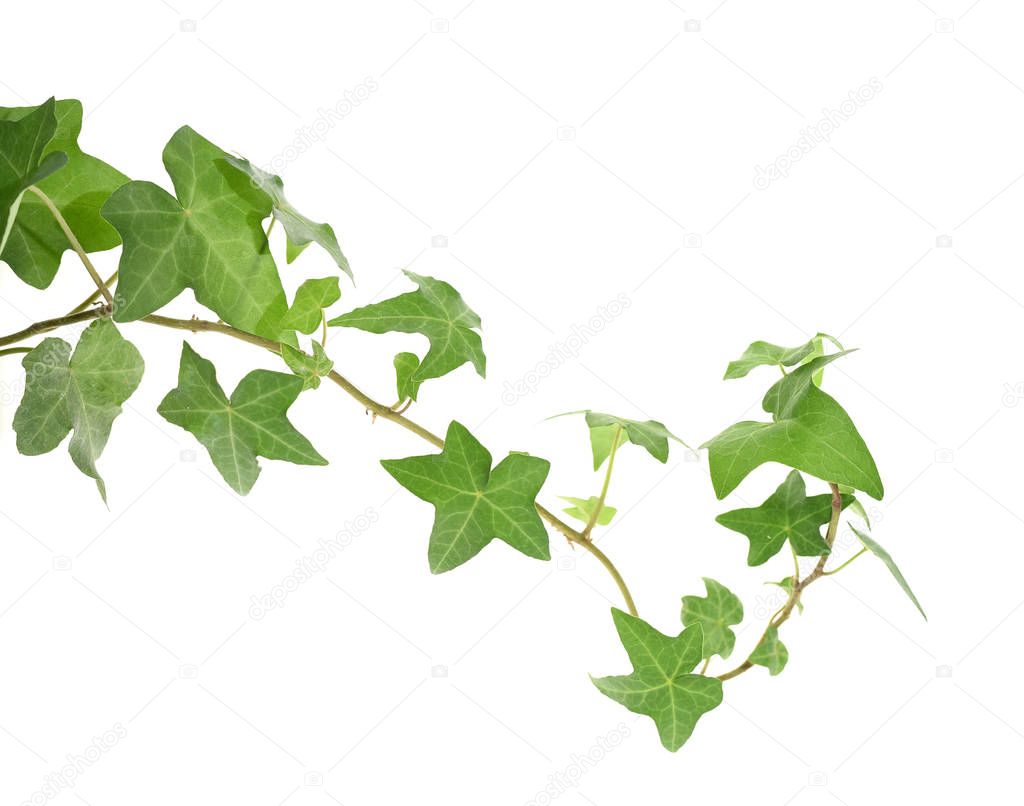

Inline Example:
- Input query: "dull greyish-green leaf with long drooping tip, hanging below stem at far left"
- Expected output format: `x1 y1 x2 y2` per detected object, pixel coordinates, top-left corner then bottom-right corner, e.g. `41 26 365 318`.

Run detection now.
14 320 144 502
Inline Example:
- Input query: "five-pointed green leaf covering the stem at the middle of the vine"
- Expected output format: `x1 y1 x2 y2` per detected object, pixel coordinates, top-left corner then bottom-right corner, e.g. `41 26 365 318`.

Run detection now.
381 421 551 574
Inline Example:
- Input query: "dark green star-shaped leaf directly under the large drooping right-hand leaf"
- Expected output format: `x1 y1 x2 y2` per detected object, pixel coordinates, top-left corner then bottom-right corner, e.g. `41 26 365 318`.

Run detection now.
715 470 853 565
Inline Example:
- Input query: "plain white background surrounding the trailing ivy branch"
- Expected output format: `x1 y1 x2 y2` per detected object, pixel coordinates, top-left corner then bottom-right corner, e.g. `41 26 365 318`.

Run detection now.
0 0 1024 806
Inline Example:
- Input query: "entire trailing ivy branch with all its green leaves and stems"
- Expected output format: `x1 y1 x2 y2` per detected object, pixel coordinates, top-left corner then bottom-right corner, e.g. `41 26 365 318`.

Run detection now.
0 98 924 751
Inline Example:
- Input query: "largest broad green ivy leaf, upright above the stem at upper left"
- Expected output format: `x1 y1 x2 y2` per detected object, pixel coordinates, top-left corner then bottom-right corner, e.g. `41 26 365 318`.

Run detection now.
103 126 288 340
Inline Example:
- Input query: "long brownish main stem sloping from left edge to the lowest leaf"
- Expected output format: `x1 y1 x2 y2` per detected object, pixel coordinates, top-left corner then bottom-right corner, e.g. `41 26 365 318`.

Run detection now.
0 304 637 616
